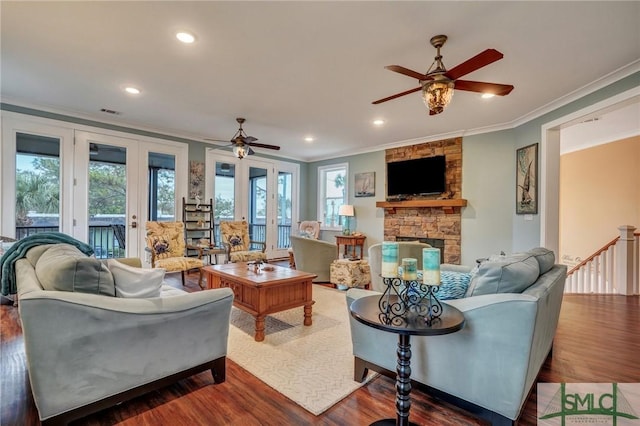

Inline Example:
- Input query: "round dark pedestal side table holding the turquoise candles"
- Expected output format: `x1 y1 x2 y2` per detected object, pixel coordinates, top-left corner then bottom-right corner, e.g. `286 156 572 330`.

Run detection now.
349 295 464 426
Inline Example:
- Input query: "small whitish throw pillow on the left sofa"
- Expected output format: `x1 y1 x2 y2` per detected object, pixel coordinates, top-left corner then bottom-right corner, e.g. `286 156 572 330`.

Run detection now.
107 259 165 298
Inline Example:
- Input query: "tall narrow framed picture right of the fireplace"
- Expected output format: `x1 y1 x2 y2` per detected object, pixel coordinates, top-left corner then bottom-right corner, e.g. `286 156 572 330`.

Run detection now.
516 143 538 214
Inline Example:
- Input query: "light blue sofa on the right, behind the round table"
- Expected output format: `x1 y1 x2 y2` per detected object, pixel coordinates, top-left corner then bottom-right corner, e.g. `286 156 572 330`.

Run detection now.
347 249 567 425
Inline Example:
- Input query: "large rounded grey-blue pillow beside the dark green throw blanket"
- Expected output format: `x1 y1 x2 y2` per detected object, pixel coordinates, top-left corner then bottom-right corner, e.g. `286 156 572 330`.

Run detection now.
36 244 115 296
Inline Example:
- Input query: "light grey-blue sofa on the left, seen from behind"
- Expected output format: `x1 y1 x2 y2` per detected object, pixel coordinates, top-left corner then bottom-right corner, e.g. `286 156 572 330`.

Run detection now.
15 244 233 424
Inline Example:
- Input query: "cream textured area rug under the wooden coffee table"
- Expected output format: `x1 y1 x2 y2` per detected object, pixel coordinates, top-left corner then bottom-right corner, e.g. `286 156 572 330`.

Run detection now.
227 285 376 415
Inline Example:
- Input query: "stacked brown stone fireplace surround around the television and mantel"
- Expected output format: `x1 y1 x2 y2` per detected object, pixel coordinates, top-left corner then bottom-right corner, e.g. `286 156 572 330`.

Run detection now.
384 138 462 264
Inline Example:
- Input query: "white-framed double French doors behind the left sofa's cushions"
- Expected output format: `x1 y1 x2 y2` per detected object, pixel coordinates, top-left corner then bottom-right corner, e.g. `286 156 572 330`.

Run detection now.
74 131 186 258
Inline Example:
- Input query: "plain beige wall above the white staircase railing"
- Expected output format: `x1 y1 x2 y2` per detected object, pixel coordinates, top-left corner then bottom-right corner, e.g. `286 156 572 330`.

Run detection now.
560 136 640 264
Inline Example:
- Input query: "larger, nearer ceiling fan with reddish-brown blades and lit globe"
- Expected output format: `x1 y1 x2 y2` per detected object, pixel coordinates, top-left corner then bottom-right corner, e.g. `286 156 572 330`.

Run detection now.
372 35 513 115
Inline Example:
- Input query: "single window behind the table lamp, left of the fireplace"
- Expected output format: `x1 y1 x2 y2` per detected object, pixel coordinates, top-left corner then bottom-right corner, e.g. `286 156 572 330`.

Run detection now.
318 163 349 229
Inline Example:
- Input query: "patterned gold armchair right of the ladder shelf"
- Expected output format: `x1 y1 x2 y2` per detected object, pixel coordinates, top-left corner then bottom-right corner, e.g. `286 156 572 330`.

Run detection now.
220 220 267 262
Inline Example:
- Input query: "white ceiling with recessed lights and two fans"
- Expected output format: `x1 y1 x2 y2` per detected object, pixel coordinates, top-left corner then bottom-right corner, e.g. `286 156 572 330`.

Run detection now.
0 1 640 161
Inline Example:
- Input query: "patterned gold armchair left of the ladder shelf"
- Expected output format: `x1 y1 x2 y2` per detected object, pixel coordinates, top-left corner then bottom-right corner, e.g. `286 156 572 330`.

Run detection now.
146 222 204 288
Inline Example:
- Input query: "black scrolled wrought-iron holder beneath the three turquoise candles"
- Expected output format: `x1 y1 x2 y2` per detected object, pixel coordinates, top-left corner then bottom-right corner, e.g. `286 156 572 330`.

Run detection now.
378 277 442 326
